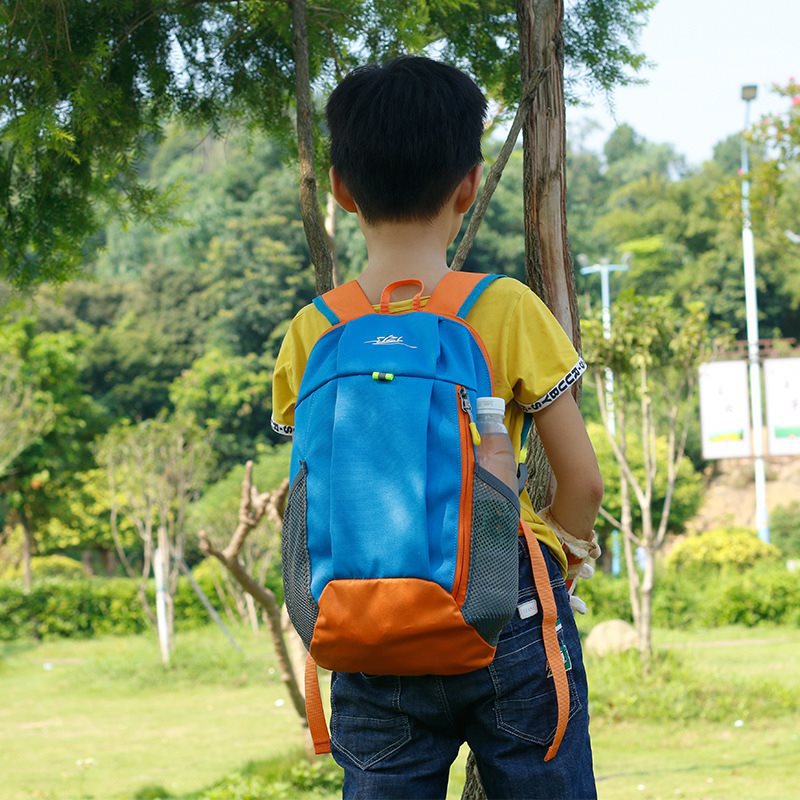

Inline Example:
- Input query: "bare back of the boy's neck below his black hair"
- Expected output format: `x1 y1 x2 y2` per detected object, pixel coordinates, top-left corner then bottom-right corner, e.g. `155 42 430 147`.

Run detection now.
358 212 453 303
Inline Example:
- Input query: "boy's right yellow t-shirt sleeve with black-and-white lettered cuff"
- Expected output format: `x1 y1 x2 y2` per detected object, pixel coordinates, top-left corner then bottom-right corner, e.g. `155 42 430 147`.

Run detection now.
508 291 586 413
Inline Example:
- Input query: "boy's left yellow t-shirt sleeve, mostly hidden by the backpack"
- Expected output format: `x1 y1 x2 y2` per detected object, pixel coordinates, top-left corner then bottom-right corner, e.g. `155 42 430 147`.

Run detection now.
272 306 330 436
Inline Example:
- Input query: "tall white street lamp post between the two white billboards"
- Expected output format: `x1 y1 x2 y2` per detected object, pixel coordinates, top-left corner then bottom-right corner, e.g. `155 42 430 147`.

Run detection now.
741 85 769 542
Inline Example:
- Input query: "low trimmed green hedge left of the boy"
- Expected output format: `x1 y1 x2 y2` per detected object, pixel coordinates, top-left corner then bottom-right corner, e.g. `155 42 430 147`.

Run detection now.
0 578 222 641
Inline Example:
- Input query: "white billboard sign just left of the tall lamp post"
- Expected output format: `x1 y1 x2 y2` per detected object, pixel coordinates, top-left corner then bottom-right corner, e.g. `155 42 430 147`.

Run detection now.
700 361 753 459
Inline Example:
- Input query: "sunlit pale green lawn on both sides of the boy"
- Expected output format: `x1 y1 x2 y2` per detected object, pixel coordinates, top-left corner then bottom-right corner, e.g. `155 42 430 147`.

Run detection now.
0 628 800 800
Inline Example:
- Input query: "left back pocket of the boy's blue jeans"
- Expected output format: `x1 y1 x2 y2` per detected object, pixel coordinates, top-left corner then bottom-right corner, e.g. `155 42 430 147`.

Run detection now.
331 672 411 769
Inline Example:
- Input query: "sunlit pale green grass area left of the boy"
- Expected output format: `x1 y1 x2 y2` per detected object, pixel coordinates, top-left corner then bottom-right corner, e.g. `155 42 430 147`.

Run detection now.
0 629 310 800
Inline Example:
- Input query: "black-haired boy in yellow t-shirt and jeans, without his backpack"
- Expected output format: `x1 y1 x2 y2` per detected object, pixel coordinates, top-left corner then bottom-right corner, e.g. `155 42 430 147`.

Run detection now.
273 57 602 800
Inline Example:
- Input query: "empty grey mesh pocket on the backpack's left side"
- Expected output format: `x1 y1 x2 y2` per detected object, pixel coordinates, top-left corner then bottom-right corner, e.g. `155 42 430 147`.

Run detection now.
281 463 319 650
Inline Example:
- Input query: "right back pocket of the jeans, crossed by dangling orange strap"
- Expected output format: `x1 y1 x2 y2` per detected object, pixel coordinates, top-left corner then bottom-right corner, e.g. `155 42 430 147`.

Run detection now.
489 628 583 745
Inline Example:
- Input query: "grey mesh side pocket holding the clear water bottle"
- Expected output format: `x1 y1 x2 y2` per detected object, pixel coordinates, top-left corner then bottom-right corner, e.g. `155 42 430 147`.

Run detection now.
461 466 519 645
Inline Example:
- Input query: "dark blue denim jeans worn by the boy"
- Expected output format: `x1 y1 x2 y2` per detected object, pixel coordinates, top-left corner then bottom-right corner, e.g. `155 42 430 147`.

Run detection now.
331 539 597 800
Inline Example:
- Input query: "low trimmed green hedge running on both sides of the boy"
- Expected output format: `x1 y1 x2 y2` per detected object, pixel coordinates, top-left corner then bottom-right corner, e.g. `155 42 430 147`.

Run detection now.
6 565 800 641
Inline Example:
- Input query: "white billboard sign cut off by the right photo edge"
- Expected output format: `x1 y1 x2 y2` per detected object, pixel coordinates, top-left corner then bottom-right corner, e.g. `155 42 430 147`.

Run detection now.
764 358 800 456
